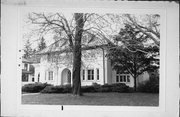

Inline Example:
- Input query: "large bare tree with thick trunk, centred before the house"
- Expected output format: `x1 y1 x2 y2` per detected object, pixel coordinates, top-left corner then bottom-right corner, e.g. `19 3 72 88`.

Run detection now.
28 13 114 95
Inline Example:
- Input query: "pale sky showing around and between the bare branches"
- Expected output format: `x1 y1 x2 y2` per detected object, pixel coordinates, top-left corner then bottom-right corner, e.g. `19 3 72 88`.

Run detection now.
22 11 160 52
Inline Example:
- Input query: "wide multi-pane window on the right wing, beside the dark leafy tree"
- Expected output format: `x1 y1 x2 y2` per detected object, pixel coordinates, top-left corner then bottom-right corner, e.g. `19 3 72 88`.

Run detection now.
116 74 130 82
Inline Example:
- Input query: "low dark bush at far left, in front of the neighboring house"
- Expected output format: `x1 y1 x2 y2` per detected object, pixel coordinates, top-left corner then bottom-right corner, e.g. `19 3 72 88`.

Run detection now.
22 83 51 93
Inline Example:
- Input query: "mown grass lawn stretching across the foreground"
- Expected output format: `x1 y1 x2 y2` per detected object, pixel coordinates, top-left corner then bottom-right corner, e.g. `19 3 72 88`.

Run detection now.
22 93 159 106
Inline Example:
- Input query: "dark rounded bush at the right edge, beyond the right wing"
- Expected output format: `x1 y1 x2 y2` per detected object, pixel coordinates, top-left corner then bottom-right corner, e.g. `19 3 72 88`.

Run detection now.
138 74 159 93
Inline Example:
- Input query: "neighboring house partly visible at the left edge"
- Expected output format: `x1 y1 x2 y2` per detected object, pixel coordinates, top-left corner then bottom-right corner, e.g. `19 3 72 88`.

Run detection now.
22 58 34 85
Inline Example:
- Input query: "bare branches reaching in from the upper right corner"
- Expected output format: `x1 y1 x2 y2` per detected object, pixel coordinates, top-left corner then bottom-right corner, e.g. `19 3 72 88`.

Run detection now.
124 14 160 47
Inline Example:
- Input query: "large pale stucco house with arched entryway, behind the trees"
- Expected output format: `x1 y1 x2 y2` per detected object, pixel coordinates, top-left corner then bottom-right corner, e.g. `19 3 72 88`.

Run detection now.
33 39 149 87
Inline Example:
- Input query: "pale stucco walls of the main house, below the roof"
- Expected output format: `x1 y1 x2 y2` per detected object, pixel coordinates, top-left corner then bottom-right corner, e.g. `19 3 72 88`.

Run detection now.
31 46 149 87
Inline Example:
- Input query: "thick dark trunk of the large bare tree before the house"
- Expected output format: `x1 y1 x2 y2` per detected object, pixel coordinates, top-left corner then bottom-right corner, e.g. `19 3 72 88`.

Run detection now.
73 13 84 96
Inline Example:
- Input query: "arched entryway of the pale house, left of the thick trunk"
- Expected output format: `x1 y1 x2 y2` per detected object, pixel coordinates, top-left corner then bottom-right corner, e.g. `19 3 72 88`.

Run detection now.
61 68 71 85
